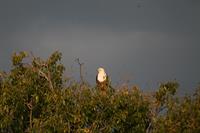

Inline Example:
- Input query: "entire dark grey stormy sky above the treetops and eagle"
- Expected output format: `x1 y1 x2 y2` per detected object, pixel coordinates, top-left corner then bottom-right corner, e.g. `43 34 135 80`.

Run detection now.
0 0 200 92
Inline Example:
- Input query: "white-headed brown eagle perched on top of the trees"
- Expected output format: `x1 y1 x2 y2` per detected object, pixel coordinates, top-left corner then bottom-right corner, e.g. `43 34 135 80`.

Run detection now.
96 67 109 93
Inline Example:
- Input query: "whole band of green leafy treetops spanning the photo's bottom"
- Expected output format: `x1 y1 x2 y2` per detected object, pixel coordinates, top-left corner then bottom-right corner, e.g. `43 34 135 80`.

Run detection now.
0 51 200 133
